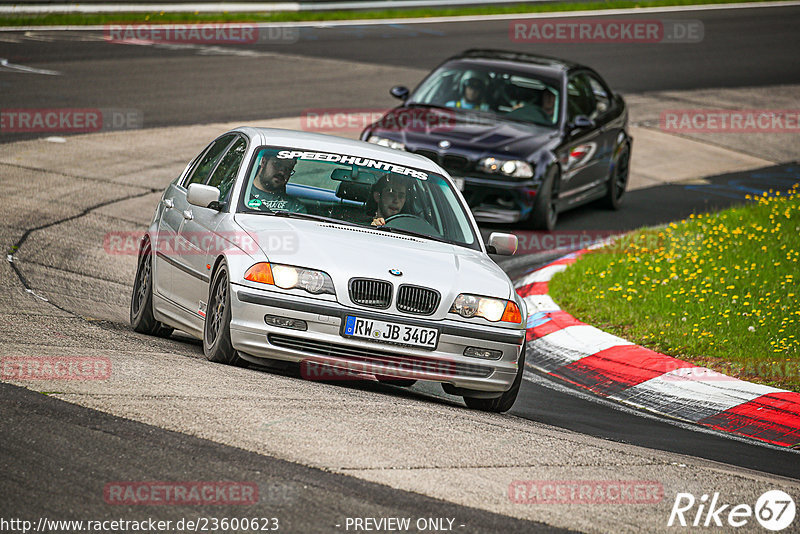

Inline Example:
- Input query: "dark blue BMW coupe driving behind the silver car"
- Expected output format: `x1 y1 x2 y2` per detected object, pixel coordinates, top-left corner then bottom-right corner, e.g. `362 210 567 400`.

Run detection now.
361 50 633 230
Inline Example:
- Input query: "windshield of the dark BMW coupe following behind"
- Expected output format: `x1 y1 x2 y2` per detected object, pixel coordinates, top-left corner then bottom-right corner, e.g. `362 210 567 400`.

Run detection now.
408 65 562 128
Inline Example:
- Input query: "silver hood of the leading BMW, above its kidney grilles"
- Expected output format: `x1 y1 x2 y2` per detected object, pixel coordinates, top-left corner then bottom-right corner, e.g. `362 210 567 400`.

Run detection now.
235 213 512 302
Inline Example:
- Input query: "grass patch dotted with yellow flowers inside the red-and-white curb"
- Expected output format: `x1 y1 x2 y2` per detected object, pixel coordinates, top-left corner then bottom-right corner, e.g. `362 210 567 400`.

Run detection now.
549 185 800 391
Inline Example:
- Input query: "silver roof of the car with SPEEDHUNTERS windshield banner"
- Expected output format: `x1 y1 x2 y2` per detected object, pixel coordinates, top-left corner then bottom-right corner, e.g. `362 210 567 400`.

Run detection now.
232 126 444 174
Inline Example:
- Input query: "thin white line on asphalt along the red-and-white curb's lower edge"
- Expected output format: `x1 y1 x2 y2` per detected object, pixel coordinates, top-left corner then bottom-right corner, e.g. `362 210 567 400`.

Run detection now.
511 369 800 454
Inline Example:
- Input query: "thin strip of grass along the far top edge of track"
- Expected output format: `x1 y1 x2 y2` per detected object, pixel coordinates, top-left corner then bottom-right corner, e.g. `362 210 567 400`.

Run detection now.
0 0 776 26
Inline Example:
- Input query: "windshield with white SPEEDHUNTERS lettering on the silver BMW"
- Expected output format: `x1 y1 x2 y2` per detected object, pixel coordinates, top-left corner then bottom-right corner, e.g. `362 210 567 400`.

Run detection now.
237 147 480 250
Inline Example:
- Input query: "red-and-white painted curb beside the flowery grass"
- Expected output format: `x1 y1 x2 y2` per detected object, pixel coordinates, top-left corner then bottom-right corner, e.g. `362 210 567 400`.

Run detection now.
514 249 800 448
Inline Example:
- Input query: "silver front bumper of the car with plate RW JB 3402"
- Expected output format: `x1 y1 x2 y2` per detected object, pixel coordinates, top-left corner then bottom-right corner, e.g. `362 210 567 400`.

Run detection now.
231 284 525 392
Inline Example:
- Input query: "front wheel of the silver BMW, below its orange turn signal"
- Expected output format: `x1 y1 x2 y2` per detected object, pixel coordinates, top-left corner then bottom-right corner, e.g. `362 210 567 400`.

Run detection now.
203 263 247 367
